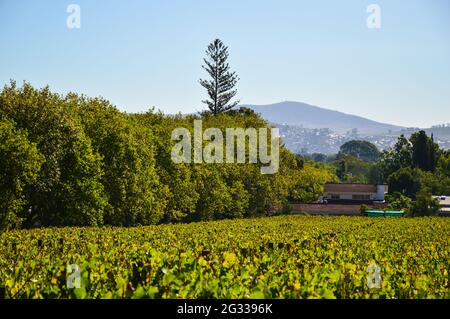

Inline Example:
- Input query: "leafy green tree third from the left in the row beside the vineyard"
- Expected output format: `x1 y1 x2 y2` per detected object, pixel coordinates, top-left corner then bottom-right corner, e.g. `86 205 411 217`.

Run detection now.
72 96 168 226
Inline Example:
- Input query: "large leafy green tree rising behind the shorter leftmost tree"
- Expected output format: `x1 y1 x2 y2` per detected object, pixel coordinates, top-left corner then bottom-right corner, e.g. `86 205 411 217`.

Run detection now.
0 82 107 226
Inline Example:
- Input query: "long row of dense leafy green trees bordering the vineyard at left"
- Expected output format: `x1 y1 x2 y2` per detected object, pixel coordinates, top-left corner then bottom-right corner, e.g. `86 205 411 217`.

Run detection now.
0 82 335 228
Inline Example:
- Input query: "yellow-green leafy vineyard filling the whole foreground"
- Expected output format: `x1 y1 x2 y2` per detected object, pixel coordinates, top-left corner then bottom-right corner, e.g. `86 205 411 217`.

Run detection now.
0 216 450 298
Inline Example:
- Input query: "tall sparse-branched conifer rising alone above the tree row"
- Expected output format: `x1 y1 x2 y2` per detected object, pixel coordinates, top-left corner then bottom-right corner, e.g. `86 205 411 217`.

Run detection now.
200 39 239 115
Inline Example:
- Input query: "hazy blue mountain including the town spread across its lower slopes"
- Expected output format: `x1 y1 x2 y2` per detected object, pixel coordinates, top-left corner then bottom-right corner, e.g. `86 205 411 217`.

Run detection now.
245 101 450 155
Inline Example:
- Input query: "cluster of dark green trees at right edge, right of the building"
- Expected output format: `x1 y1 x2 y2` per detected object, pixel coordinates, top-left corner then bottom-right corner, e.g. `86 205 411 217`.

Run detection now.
375 131 450 215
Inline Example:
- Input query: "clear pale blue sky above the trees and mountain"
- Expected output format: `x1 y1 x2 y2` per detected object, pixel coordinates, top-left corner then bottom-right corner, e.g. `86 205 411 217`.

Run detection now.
0 0 450 127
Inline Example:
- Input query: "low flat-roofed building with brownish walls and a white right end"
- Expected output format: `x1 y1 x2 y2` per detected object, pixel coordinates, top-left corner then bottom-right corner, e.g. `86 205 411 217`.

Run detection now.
324 183 388 203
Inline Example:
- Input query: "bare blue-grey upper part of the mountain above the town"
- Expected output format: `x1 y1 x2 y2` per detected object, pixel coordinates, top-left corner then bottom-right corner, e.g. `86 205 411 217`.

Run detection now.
243 101 404 134
